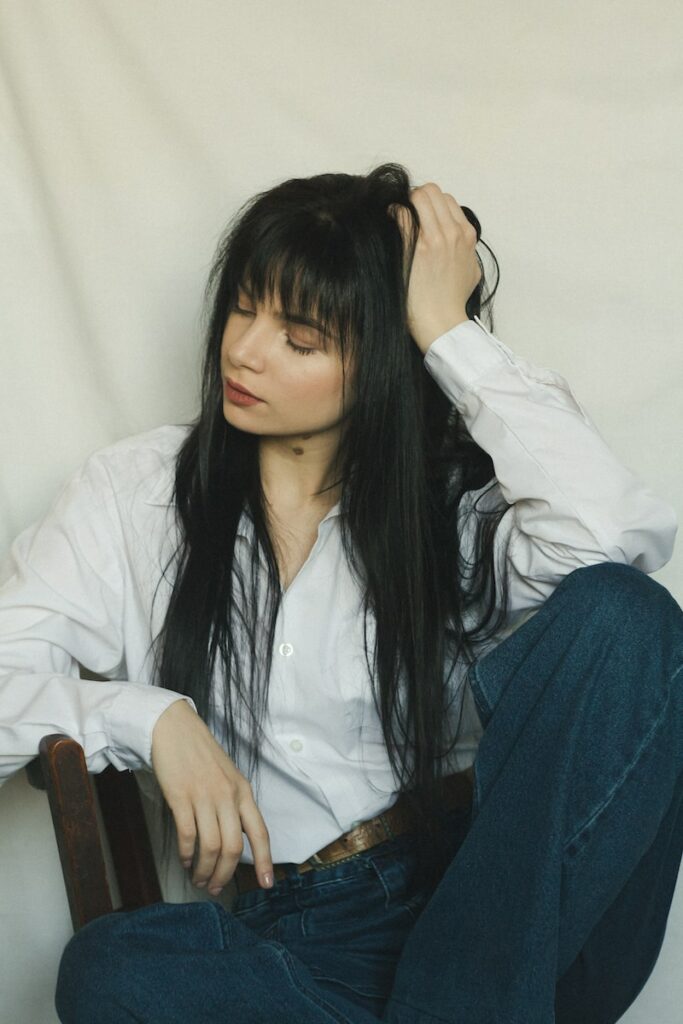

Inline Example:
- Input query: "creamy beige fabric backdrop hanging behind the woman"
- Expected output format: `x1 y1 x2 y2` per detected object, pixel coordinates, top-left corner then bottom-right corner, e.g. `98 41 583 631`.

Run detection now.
0 0 683 1024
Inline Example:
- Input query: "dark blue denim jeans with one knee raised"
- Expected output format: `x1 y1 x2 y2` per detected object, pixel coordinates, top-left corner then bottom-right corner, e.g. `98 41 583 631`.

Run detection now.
55 563 683 1024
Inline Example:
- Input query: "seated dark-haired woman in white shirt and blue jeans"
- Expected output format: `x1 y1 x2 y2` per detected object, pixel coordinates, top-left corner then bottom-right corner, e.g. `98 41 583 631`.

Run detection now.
0 164 683 1024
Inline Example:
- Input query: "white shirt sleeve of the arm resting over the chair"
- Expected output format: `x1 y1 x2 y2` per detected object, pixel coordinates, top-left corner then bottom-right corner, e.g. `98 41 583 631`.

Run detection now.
0 455 197 784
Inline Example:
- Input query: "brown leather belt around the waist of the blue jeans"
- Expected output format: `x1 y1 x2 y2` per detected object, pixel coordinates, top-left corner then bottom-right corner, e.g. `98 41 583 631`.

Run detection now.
233 768 474 895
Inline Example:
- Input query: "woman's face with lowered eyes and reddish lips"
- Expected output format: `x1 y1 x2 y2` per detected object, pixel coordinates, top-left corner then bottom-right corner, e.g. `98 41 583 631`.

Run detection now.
220 288 350 437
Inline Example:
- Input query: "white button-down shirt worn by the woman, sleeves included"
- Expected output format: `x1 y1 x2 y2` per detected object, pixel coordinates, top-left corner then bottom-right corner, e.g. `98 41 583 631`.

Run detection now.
0 318 677 863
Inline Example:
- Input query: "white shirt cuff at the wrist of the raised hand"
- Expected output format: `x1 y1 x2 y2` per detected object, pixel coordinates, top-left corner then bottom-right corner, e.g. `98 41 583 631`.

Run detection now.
424 316 515 403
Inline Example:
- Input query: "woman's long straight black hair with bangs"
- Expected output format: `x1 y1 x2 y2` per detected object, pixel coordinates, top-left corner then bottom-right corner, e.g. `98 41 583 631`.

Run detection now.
149 163 509 897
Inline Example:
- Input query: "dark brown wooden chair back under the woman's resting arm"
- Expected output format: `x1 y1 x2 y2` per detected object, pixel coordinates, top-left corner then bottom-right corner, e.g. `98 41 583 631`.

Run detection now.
26 733 163 932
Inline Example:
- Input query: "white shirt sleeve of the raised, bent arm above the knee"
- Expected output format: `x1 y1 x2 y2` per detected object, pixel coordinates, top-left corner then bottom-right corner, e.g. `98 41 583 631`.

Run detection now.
425 317 678 612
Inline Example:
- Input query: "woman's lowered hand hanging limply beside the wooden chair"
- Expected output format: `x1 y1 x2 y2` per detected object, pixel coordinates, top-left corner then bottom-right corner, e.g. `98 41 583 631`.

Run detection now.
152 700 273 896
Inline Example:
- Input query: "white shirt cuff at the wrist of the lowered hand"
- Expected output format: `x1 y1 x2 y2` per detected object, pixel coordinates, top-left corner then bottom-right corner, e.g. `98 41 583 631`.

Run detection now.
106 683 197 771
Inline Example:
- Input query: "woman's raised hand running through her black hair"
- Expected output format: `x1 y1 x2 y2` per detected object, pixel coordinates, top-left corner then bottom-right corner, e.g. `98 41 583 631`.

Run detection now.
389 181 481 355
